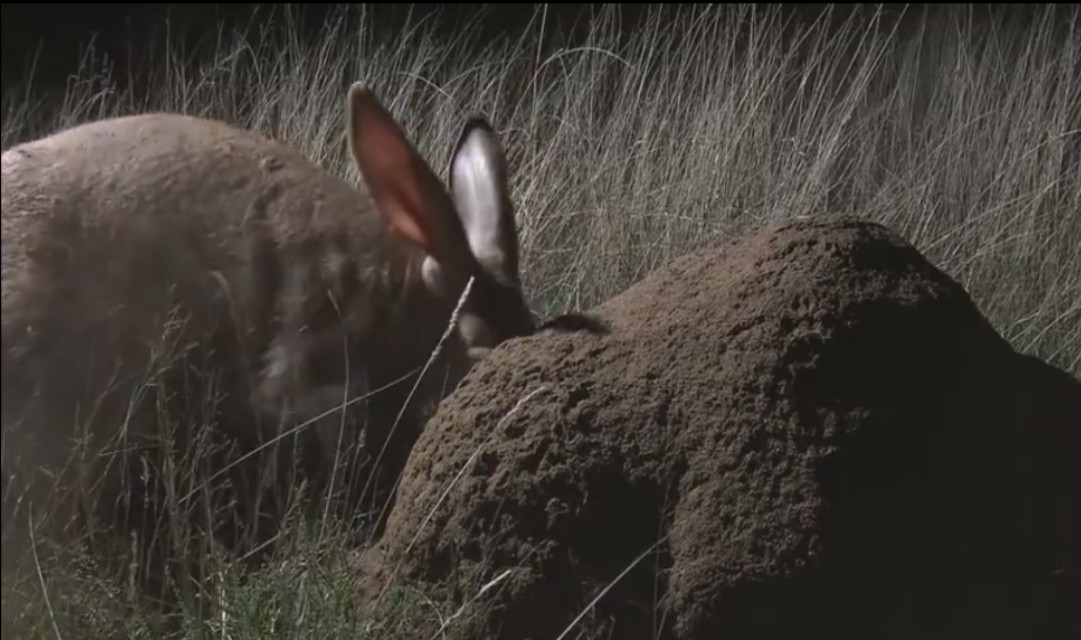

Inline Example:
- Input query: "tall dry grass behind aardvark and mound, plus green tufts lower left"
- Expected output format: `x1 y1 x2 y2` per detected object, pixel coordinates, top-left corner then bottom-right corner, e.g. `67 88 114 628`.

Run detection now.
2 5 1081 638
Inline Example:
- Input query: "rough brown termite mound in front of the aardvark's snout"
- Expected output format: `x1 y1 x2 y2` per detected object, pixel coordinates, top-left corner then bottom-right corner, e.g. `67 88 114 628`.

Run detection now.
360 218 1081 638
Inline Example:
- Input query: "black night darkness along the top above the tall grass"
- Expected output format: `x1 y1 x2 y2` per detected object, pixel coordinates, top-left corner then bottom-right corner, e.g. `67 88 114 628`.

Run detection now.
0 3 1046 101
